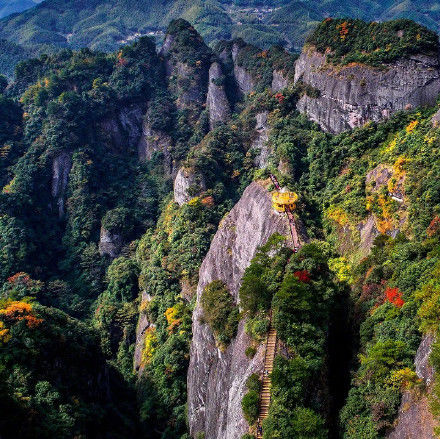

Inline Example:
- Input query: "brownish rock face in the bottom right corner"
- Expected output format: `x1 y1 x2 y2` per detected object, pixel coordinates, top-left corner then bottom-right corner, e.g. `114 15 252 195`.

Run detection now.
387 335 439 439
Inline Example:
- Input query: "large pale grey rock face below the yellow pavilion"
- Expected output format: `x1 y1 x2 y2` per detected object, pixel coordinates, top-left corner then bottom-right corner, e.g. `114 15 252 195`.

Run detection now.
188 182 288 439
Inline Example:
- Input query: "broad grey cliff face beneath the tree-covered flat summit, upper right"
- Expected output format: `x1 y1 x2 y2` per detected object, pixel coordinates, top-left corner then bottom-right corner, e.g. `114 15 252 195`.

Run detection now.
295 47 440 133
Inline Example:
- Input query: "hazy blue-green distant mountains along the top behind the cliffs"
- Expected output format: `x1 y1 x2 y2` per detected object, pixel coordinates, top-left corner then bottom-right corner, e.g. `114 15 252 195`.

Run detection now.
0 0 440 76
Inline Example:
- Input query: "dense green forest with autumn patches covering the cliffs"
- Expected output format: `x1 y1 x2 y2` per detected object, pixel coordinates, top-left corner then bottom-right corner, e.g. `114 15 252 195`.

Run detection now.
4 13 440 439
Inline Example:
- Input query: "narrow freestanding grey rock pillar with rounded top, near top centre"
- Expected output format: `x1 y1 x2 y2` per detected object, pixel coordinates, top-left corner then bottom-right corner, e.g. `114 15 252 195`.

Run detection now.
206 62 231 130
